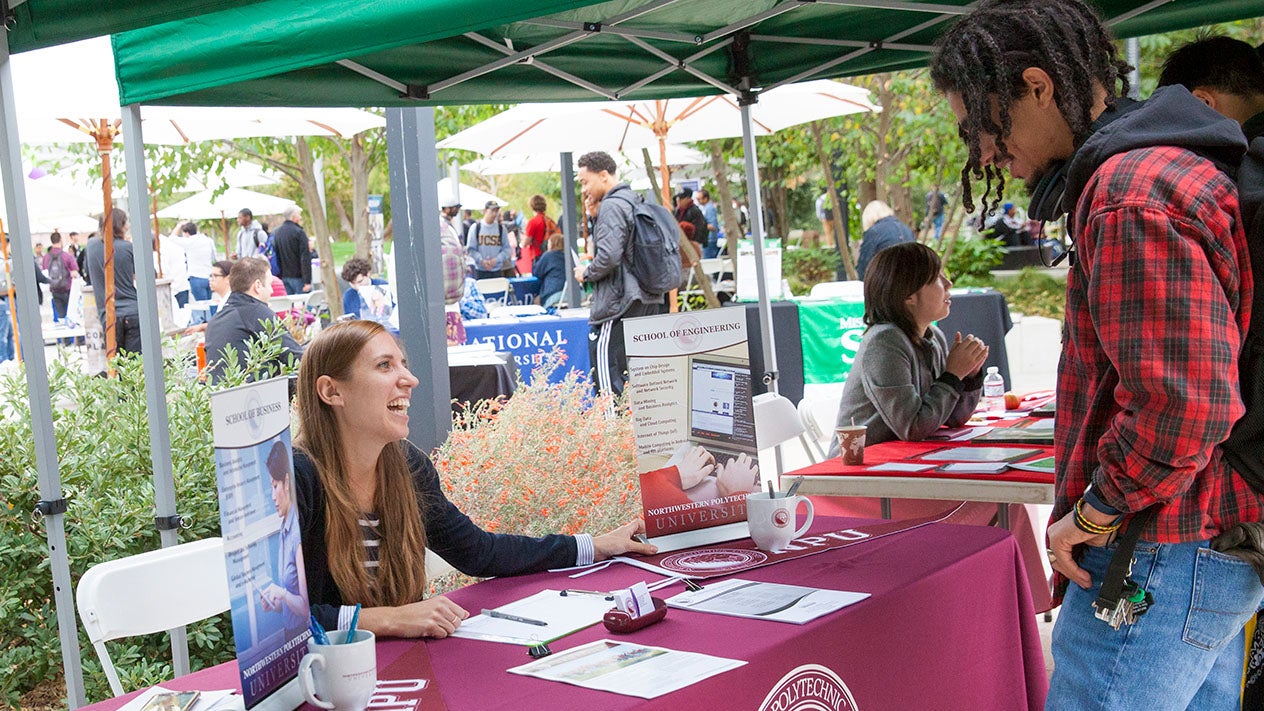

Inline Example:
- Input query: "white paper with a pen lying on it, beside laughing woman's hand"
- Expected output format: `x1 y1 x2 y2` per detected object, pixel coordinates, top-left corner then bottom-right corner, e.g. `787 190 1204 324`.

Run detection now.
451 590 614 645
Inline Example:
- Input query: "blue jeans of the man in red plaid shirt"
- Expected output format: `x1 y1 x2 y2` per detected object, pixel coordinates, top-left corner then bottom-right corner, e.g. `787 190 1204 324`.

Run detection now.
1045 541 1264 711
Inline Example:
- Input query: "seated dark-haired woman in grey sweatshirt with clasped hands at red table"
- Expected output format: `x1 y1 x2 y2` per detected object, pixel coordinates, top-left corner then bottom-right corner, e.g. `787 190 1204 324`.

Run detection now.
829 242 987 457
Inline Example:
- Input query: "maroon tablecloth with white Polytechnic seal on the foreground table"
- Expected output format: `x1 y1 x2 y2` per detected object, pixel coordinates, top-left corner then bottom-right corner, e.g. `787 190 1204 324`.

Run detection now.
81 517 1047 711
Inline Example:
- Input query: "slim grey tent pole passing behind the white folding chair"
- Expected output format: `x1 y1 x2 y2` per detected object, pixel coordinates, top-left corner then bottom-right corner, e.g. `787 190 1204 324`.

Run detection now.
123 104 188 677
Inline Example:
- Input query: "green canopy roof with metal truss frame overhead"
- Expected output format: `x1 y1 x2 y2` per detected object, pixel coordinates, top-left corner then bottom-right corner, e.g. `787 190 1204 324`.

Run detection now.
114 0 1264 106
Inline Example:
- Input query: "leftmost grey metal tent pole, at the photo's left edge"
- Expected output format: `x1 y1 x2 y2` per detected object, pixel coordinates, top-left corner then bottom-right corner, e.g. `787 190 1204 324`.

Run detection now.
0 24 85 708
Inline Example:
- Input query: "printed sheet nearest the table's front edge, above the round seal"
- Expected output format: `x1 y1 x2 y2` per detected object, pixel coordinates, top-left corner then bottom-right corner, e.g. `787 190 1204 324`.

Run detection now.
508 639 746 698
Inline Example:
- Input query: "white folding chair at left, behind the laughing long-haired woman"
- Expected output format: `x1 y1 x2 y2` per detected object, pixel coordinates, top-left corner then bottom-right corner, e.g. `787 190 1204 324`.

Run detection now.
76 538 229 696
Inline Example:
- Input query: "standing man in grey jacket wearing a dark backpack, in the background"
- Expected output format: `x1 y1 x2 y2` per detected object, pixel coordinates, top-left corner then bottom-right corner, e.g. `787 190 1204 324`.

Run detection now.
575 151 680 393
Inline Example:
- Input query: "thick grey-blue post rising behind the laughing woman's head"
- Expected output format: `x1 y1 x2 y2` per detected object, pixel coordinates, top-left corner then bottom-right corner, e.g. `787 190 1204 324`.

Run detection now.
387 106 453 452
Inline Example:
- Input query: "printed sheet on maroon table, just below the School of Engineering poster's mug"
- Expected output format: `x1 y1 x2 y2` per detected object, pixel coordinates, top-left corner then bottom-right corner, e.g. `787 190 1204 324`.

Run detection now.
667 578 870 625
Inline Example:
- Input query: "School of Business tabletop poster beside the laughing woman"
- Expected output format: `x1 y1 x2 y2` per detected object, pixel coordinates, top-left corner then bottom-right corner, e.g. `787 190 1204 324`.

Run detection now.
211 377 310 708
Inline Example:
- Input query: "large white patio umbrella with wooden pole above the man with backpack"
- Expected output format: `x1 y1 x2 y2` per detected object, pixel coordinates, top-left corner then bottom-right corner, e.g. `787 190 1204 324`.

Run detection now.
437 80 881 205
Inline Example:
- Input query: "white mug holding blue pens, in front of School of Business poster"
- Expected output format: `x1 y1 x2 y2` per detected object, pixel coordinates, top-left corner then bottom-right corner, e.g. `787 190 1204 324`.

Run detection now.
298 630 378 711
